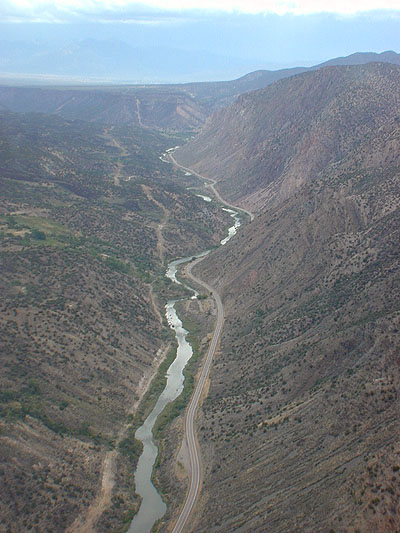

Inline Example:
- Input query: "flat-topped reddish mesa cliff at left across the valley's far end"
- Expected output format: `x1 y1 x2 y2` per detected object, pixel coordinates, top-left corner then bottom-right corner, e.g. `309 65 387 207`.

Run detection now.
0 86 208 130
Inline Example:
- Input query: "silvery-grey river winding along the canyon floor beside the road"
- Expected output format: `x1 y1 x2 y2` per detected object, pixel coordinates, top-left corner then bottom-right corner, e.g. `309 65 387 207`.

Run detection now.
129 195 241 533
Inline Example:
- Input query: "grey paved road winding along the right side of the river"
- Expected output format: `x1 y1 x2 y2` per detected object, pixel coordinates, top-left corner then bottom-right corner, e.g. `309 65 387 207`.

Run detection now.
168 153 254 533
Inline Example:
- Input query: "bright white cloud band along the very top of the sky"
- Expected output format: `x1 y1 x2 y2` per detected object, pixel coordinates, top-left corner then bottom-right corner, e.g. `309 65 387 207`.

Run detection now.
0 0 399 24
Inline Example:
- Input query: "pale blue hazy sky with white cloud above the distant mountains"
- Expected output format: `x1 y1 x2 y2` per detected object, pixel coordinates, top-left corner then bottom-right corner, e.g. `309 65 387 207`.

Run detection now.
0 0 400 81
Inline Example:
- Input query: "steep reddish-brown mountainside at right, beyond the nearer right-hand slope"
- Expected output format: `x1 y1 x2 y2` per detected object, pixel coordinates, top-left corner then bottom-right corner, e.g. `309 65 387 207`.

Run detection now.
176 63 400 210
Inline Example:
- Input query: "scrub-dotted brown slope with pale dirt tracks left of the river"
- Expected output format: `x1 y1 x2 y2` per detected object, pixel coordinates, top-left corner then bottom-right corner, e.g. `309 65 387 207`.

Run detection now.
0 113 231 532
